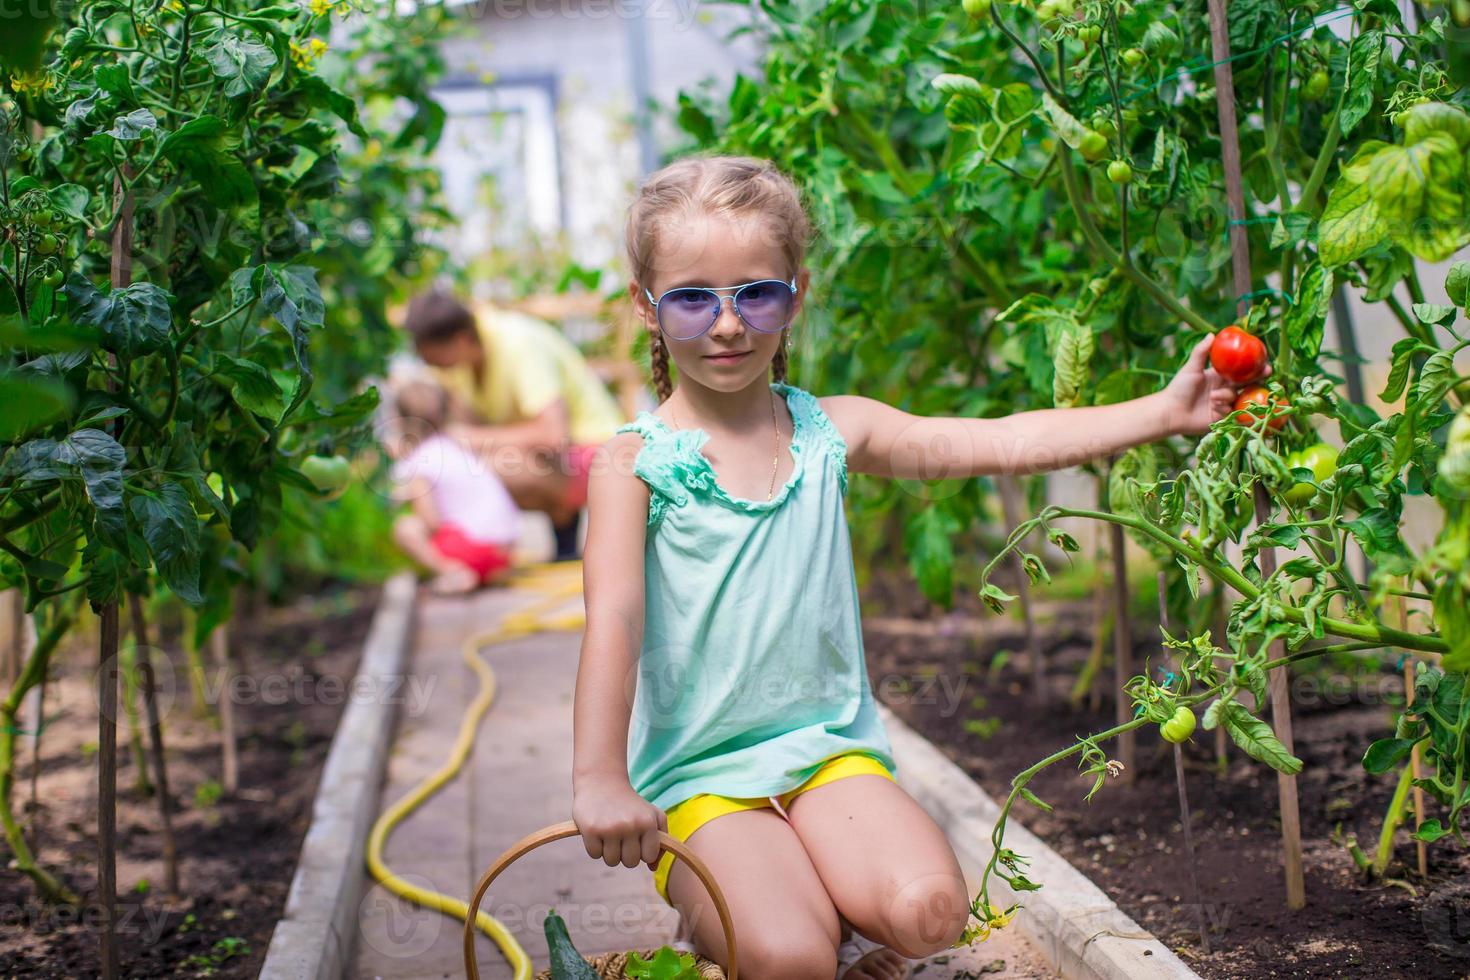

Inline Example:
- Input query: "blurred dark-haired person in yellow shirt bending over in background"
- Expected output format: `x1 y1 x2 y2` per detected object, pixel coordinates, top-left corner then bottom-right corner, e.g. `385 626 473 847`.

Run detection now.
404 291 625 561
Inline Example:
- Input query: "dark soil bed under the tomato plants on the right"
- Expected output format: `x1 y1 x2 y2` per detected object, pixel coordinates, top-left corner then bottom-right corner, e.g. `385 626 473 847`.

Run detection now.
864 577 1470 979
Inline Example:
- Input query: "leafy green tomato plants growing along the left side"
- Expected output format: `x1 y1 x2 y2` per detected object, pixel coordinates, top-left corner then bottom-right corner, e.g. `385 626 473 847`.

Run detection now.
0 0 444 970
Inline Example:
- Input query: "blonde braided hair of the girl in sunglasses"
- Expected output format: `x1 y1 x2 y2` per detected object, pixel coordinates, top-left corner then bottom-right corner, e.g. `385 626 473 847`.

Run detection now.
625 156 811 401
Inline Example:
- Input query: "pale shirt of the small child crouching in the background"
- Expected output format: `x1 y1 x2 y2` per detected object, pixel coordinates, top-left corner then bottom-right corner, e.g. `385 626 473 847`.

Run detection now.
390 433 520 544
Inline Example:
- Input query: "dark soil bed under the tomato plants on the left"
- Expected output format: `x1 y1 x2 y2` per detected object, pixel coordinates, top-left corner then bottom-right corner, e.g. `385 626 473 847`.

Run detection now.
0 589 378 980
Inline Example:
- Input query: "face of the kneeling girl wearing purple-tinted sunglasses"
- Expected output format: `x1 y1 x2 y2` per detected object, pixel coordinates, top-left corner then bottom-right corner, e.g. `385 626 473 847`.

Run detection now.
628 212 810 391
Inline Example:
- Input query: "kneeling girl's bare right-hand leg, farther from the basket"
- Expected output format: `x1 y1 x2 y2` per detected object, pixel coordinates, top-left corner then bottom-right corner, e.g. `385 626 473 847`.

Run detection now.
786 773 970 959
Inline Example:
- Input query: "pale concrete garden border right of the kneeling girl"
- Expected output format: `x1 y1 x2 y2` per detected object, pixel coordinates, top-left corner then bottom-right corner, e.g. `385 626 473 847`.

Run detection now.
878 705 1200 980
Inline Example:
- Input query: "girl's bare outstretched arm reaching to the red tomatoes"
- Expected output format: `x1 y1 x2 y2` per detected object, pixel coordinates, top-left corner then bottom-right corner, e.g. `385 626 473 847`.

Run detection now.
822 334 1235 479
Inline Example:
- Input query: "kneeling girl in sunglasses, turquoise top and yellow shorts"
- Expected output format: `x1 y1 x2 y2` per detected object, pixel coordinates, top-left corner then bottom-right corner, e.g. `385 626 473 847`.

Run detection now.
572 157 1233 980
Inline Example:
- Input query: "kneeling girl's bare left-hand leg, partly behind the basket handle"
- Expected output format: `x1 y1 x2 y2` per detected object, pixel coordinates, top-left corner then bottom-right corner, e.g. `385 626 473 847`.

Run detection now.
669 811 839 980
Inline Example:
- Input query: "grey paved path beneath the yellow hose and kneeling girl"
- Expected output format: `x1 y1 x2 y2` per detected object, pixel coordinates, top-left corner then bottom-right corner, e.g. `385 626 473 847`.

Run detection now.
350 517 1050 980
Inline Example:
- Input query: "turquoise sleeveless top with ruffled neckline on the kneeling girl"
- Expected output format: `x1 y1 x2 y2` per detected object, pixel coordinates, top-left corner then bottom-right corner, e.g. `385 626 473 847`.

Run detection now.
619 382 898 811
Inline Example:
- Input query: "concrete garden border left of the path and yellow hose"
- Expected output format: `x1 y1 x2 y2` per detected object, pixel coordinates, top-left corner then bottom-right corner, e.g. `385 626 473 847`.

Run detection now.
260 572 417 980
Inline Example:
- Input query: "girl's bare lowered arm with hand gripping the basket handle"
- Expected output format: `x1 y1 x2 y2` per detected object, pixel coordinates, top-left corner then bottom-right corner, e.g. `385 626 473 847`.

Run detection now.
572 432 669 867
